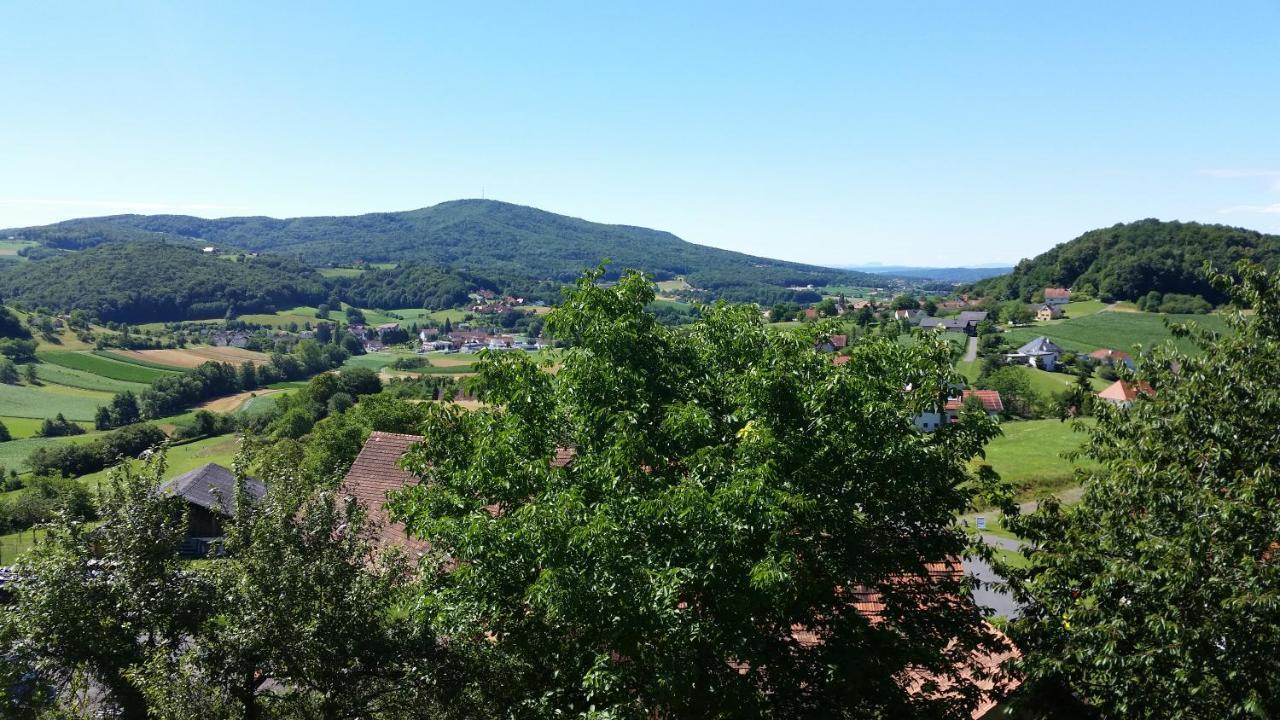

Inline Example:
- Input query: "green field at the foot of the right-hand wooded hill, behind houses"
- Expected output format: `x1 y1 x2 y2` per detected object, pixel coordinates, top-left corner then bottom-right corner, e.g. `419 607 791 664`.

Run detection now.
1005 311 1226 352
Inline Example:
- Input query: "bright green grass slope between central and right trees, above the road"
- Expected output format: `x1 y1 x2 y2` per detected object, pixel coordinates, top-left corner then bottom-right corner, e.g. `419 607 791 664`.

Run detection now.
986 420 1088 498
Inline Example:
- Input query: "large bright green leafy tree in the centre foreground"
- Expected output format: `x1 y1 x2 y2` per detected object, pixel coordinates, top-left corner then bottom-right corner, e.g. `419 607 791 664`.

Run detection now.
396 269 1000 719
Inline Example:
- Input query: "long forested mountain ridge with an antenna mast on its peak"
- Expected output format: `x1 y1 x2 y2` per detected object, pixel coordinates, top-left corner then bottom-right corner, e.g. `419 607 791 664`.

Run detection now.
6 200 886 301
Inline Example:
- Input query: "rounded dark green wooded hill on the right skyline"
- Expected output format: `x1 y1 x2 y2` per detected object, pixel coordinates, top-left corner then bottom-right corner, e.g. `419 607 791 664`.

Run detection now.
972 219 1280 304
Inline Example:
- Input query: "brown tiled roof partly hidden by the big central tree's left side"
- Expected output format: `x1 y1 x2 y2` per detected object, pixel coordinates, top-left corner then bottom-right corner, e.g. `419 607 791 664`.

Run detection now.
338 432 430 556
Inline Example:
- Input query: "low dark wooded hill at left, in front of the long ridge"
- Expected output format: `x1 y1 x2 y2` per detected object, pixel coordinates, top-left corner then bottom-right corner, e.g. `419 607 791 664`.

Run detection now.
0 242 326 323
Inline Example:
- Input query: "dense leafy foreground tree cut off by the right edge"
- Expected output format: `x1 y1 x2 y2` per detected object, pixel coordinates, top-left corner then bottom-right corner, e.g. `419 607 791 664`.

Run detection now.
1006 260 1280 719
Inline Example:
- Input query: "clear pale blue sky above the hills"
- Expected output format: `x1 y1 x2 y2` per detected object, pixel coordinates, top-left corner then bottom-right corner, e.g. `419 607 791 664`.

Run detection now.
0 0 1280 264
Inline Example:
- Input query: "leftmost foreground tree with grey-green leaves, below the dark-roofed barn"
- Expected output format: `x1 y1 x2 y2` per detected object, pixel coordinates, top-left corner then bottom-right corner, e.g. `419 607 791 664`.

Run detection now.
5 456 206 719
